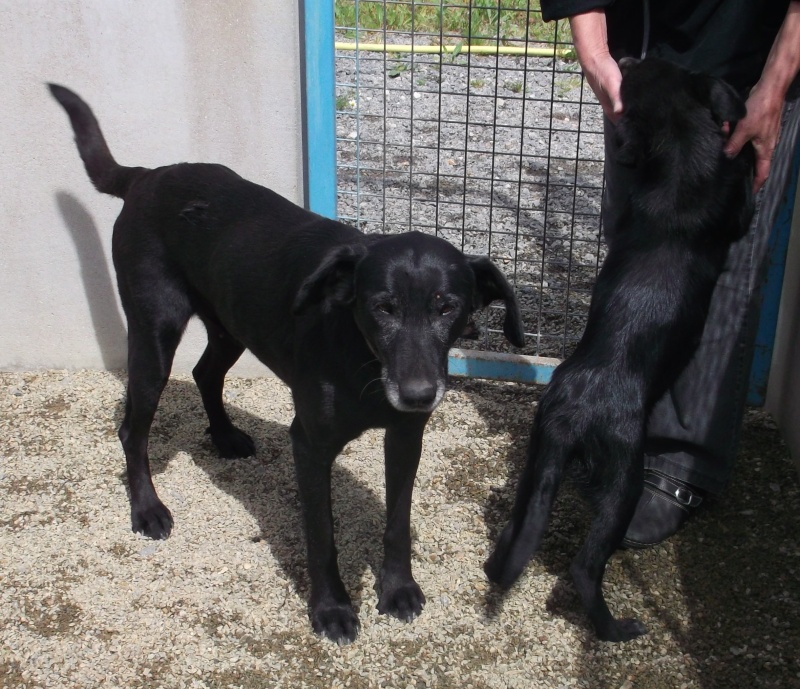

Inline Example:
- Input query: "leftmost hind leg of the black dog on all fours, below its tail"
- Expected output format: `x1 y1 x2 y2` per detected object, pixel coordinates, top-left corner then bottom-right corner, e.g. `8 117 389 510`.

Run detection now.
119 281 192 539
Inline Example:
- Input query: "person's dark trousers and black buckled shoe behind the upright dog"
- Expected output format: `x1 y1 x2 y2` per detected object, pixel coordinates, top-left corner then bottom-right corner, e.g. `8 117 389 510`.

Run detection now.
603 86 800 545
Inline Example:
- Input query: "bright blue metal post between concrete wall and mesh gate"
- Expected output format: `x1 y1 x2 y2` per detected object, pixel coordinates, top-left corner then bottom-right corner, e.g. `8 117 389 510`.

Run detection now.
303 0 336 218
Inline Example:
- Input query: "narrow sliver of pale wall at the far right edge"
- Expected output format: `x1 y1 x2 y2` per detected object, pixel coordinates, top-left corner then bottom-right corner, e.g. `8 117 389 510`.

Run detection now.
766 183 800 470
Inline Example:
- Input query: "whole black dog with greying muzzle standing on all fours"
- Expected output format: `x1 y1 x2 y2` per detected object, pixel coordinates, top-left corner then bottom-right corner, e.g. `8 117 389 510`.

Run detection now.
50 84 523 641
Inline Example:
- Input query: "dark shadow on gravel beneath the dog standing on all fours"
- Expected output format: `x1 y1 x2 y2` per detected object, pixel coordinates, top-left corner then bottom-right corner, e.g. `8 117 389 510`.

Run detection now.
114 375 385 610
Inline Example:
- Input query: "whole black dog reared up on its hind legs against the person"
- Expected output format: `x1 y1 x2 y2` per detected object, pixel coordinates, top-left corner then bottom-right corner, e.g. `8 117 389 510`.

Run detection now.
485 59 753 641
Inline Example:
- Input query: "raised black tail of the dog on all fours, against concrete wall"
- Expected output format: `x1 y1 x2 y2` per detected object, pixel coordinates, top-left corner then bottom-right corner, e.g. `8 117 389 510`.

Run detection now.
48 84 143 198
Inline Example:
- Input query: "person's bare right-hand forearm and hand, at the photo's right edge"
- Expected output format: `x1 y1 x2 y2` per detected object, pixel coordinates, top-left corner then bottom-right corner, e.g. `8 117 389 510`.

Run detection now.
725 0 800 191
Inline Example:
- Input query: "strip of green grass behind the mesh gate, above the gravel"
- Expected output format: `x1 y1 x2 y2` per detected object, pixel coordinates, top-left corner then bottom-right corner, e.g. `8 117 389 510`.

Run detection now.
334 0 571 45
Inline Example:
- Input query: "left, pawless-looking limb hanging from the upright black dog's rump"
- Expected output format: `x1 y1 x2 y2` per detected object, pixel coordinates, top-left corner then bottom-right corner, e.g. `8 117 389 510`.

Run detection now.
483 411 572 588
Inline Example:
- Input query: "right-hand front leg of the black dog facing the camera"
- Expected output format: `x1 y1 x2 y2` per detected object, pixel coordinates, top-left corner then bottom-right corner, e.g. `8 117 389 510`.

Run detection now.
378 414 428 622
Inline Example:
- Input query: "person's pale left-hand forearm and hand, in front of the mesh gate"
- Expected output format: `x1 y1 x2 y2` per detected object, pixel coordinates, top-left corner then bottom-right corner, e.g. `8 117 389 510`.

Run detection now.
569 9 622 122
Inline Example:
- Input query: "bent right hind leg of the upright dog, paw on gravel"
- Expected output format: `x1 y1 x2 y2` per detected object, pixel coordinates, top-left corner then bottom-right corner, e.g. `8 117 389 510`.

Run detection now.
570 441 647 641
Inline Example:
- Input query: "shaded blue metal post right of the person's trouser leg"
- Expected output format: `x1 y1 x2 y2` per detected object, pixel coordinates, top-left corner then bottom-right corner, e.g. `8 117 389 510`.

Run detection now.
747 146 800 407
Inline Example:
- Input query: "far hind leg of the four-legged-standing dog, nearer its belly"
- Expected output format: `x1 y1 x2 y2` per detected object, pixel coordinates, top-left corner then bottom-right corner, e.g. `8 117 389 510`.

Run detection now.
192 318 256 458
